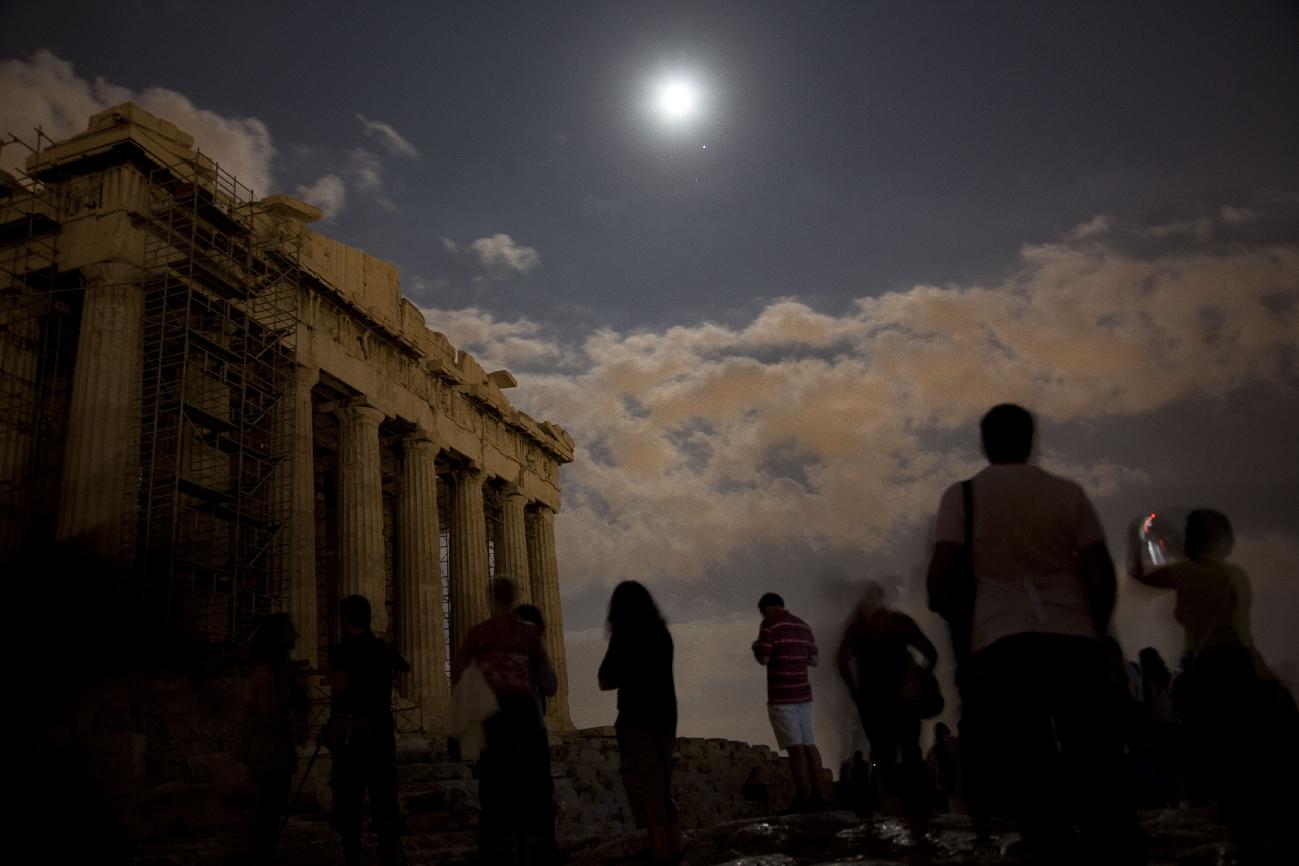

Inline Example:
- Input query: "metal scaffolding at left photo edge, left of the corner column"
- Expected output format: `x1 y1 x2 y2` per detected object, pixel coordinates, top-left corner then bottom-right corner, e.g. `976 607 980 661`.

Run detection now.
0 129 74 556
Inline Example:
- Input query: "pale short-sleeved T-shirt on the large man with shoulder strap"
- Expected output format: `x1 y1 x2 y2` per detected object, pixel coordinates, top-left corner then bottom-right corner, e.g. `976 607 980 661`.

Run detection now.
935 464 1105 650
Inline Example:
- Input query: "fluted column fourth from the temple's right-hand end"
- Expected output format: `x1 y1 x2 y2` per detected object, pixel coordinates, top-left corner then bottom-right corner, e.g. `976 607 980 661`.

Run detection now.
395 432 448 716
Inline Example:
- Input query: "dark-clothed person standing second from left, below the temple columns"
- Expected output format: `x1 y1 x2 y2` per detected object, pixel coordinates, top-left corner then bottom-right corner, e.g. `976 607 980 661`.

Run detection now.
325 596 410 866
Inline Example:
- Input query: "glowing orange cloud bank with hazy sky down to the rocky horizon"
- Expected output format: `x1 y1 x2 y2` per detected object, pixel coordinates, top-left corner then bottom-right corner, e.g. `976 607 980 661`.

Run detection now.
426 198 1299 745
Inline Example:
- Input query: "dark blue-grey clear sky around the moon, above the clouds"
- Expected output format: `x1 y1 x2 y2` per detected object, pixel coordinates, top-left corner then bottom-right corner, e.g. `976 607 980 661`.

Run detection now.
0 0 1299 328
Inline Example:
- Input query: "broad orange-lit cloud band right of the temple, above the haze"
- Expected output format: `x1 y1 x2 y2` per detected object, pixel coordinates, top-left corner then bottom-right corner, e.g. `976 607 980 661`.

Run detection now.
430 201 1299 602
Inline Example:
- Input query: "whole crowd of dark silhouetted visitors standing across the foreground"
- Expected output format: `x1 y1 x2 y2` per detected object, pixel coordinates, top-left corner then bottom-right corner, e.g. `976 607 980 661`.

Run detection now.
32 394 1299 866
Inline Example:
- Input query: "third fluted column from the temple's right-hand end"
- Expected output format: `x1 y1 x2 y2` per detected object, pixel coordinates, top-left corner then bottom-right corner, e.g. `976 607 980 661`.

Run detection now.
449 467 491 657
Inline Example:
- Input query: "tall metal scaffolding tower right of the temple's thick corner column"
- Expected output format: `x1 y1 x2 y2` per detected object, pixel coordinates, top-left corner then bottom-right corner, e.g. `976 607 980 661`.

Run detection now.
138 155 301 641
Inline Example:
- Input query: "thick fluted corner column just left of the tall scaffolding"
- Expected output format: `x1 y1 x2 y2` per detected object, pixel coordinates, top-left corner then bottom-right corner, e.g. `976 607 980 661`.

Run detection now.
56 264 144 560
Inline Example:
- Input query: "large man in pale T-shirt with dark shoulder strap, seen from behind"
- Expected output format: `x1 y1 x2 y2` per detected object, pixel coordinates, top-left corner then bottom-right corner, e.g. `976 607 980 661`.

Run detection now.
929 404 1142 863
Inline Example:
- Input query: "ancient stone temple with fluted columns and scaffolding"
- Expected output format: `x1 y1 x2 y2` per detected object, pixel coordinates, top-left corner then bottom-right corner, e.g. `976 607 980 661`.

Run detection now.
0 104 573 726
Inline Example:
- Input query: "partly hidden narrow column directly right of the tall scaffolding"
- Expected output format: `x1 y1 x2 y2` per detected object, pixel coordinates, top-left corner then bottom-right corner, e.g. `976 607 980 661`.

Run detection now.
284 366 320 667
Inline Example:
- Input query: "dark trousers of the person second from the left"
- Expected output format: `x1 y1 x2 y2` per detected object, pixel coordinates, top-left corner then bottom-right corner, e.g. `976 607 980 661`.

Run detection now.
330 722 400 866
